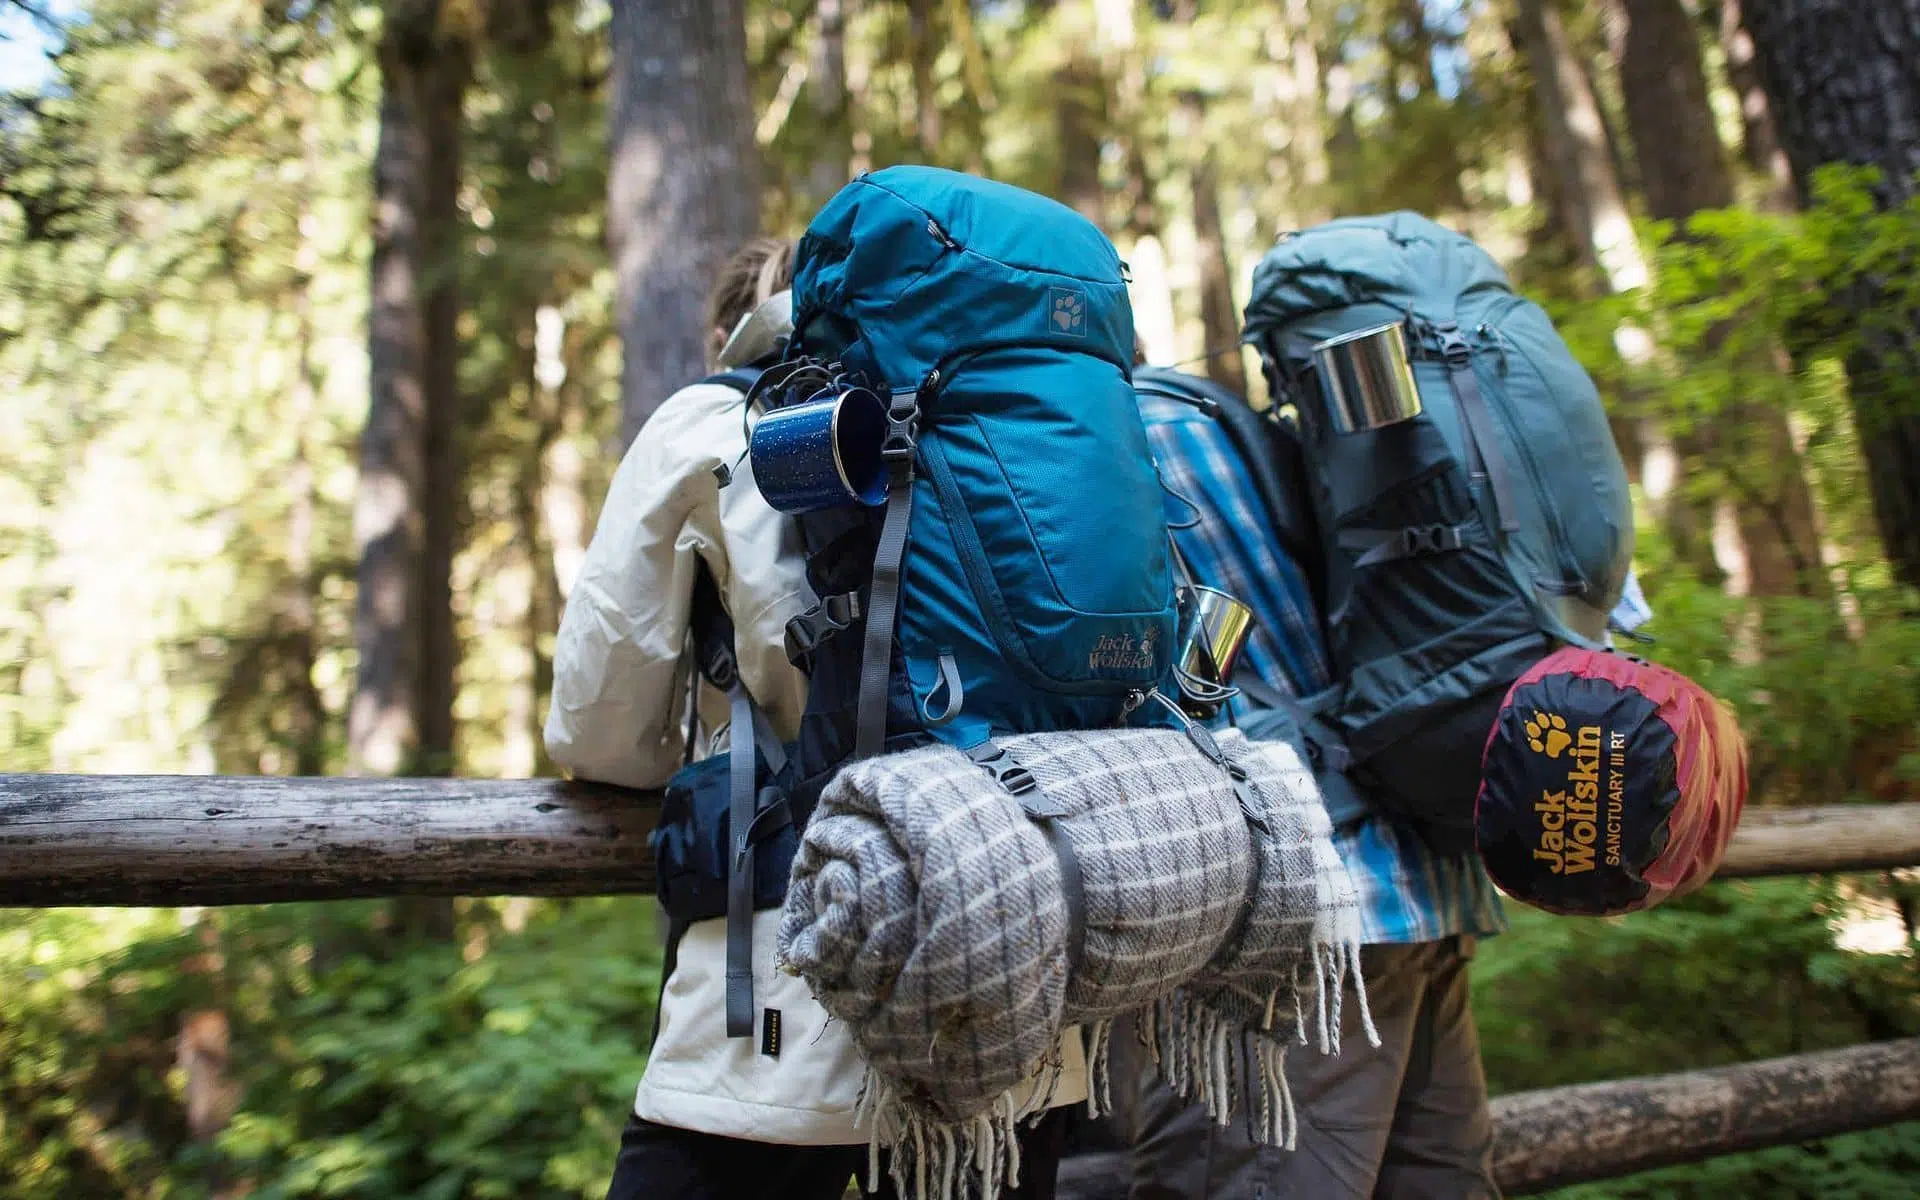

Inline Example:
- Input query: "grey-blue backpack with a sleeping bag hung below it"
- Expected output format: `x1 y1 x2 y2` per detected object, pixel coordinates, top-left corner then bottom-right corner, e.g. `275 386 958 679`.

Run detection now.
1244 213 1634 849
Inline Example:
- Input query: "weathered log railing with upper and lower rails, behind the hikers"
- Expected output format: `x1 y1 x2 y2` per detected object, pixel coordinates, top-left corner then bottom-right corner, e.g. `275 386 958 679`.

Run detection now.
0 776 1920 1200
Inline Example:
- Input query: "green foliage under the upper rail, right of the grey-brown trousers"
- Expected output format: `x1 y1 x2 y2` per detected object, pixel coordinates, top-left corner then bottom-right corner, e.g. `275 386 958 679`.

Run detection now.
1473 877 1920 1200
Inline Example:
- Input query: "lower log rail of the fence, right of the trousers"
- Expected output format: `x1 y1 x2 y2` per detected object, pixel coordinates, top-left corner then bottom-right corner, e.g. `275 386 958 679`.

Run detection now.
1058 1039 1920 1200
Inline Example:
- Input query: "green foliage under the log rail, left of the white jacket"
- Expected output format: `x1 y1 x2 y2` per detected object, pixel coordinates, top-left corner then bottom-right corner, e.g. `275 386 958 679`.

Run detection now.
0 899 659 1200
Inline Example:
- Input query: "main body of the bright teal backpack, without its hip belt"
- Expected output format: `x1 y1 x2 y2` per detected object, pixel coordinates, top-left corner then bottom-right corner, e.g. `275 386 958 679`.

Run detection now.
783 167 1175 774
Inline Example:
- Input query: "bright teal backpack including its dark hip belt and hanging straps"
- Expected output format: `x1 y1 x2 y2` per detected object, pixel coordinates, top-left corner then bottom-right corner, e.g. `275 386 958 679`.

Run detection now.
668 167 1190 1037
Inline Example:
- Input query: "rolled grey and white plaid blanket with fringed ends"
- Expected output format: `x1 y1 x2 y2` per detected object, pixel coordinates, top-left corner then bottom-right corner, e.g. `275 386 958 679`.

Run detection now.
780 730 1365 1200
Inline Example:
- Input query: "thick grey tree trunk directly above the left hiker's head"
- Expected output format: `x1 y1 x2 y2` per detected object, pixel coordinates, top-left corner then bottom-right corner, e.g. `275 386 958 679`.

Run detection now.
607 0 760 442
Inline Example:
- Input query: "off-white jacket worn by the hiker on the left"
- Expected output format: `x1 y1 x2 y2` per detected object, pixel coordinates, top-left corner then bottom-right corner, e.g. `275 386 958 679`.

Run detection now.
545 384 1087 1146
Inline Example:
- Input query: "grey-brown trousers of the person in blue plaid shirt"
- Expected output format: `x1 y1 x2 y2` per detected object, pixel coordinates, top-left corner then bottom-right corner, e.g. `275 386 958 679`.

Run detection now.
1112 937 1500 1200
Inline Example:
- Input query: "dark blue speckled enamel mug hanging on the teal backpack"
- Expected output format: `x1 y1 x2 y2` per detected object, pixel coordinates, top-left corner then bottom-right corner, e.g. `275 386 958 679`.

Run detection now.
747 388 887 513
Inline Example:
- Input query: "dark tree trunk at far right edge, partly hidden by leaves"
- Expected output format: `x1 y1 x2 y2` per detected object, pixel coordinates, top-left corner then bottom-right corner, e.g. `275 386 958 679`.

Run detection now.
1743 0 1920 588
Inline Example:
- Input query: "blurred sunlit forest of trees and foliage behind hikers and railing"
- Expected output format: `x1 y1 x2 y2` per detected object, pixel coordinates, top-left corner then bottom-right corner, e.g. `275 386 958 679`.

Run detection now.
0 0 1920 1200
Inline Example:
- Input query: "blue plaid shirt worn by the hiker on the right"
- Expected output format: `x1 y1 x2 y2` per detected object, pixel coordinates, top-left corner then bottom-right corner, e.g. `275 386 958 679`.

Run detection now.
1140 387 1507 943
